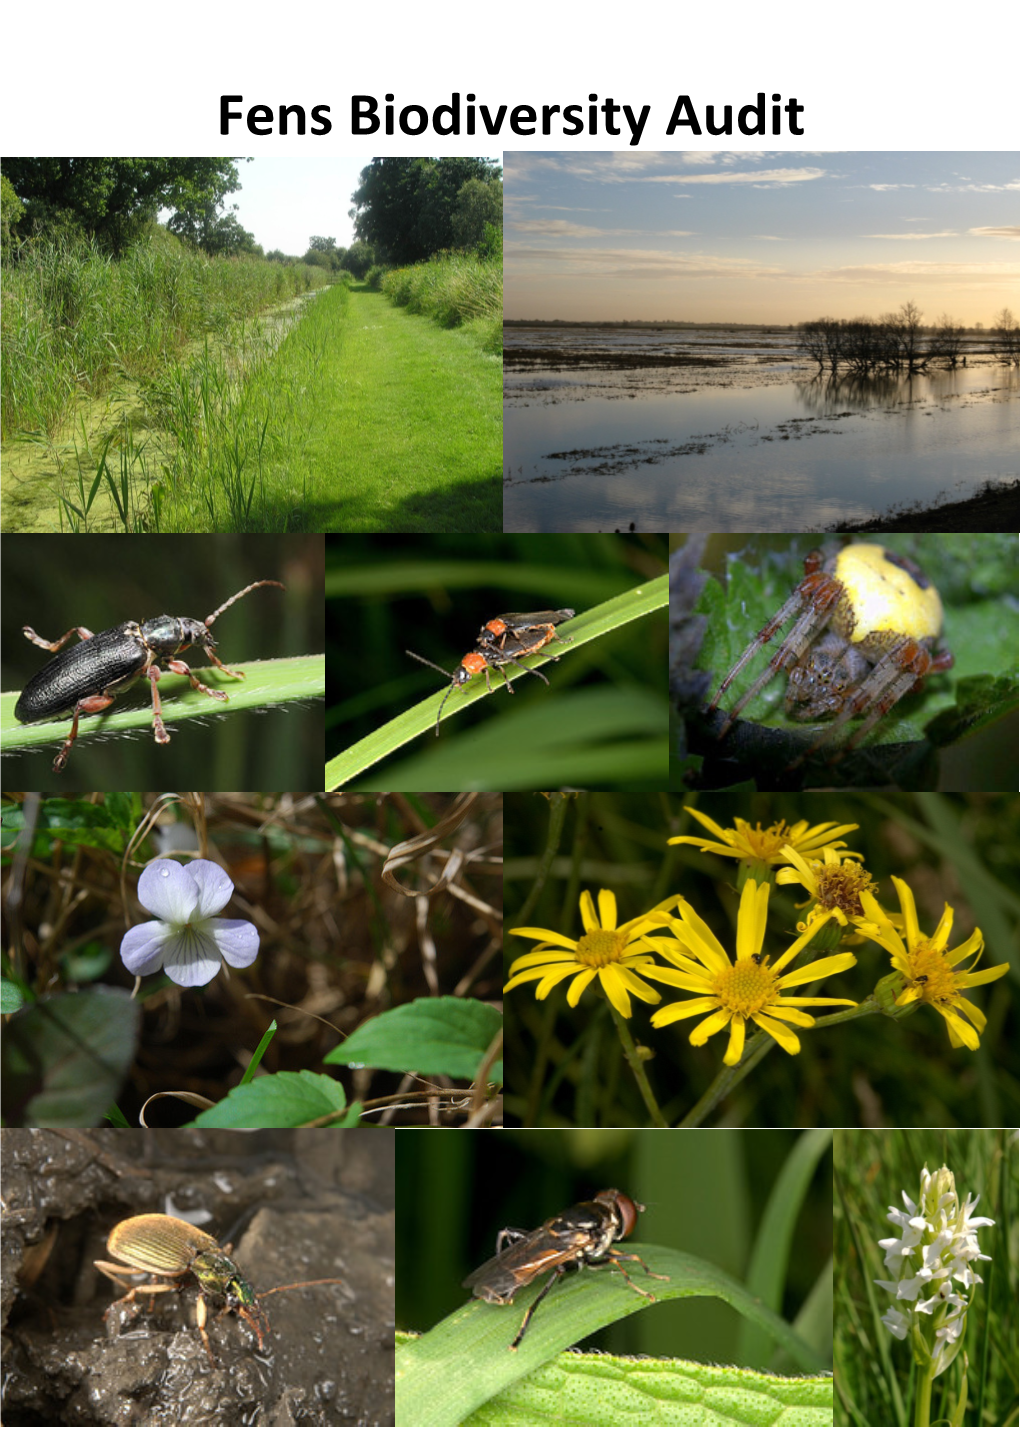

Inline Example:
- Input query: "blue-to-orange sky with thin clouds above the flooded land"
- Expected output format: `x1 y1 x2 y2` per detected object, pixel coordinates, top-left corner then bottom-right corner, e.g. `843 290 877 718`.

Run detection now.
504 150 1020 326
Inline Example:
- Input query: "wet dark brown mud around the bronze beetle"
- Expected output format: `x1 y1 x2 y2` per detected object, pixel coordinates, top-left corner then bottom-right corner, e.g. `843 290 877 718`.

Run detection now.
0 1128 394 1427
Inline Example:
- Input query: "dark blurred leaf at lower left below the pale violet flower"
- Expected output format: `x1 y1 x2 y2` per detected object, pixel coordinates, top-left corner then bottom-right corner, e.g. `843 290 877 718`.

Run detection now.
1 987 141 1127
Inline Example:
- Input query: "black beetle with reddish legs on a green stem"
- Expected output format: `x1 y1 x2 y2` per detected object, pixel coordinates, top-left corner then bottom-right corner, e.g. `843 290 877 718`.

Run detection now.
14 582 286 772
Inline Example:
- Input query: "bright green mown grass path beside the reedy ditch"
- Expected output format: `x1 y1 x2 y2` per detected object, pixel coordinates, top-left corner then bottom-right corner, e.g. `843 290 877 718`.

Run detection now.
267 286 504 531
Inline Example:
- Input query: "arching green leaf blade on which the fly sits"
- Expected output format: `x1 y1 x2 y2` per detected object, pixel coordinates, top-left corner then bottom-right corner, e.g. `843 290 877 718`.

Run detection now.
397 1247 824 1427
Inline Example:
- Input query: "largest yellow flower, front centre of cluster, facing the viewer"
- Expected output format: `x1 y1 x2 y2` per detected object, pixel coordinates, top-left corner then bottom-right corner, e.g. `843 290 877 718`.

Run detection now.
645 879 857 1066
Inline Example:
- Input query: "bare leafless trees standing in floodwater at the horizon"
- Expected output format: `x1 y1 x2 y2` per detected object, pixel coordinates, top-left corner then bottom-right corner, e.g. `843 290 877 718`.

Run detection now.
796 300 1020 375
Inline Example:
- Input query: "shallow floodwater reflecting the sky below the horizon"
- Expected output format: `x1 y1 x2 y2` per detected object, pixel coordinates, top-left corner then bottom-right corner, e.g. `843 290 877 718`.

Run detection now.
504 326 1020 531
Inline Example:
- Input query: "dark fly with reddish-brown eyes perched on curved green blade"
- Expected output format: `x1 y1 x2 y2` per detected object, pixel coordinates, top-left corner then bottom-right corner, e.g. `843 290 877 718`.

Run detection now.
462 1188 665 1349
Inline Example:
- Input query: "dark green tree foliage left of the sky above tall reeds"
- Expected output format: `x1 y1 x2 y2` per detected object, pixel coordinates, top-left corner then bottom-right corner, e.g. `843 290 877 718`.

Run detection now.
3 156 241 254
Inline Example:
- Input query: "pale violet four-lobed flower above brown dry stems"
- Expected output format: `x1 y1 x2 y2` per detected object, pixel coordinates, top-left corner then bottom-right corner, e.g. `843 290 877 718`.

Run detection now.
120 857 258 987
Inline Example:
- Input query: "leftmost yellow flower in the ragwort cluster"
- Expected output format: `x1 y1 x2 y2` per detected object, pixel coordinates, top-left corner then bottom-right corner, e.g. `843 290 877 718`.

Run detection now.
504 889 677 1017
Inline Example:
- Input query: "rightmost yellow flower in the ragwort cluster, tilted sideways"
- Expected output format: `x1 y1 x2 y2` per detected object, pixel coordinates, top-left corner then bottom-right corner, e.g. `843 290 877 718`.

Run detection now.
858 877 1010 1052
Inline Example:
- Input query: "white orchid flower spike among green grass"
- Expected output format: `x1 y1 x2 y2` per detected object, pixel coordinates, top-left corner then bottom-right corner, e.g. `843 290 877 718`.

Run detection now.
876 1167 995 1378
